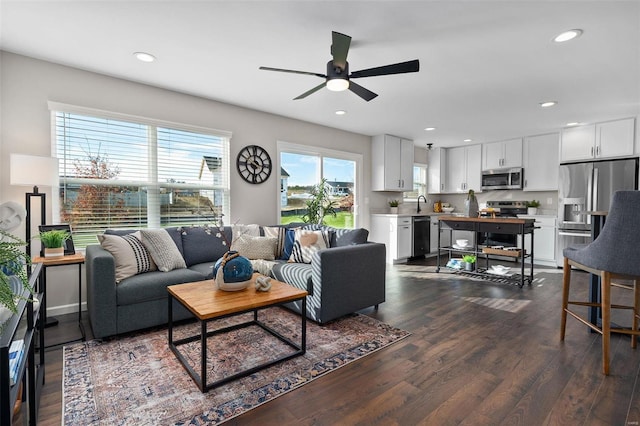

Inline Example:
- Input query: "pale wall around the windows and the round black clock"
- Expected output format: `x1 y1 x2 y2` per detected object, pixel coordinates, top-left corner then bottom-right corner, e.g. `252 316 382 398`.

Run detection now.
0 52 384 314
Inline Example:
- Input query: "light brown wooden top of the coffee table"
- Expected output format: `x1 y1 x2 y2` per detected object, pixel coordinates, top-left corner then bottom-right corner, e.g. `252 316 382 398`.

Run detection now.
167 273 307 320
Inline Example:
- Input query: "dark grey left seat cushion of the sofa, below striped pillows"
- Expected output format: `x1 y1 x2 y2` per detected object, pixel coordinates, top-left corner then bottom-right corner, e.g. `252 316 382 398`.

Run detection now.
116 269 205 306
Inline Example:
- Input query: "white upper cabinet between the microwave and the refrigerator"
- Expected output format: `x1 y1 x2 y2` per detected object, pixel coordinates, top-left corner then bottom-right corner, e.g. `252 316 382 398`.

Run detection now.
522 133 560 191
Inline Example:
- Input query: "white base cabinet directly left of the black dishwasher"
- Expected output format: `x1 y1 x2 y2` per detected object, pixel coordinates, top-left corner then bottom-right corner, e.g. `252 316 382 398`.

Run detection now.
369 215 413 264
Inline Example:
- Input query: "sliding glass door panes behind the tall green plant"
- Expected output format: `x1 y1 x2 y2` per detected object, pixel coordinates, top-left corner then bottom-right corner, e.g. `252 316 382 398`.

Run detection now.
278 142 362 228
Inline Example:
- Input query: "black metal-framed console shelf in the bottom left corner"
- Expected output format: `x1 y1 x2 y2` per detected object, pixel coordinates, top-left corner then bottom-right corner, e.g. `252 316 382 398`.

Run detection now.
0 263 44 425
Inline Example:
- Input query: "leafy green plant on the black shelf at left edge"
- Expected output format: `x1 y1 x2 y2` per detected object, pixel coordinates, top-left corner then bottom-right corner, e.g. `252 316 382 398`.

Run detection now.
0 230 33 314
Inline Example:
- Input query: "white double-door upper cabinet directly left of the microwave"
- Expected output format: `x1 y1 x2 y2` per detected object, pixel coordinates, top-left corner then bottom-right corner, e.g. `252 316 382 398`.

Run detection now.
445 145 482 193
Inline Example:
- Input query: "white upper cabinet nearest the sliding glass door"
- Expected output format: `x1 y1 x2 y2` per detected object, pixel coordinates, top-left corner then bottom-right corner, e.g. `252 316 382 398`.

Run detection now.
371 135 413 191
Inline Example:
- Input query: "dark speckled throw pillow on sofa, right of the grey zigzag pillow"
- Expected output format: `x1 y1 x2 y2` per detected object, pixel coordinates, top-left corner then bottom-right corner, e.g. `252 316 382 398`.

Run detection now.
179 226 231 267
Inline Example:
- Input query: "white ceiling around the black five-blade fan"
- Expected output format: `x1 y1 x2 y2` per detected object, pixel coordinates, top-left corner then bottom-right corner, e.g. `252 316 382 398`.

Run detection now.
0 0 640 146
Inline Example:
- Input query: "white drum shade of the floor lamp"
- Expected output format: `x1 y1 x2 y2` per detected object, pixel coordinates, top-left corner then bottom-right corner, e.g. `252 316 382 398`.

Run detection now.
10 154 58 186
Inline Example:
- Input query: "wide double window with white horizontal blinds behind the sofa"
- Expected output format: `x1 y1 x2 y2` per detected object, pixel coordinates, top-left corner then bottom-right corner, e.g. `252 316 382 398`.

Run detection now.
52 104 230 247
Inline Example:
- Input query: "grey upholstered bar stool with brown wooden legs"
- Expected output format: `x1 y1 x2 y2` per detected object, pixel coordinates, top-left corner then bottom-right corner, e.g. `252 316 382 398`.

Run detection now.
560 191 640 375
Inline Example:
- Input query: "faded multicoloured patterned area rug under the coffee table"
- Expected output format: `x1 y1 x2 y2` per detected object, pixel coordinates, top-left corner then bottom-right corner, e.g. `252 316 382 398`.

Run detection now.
62 308 410 425
